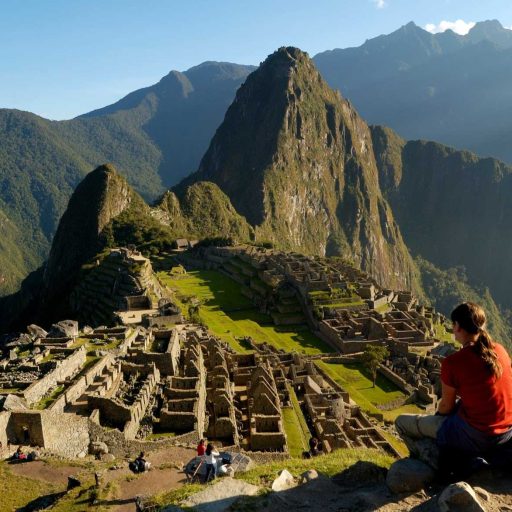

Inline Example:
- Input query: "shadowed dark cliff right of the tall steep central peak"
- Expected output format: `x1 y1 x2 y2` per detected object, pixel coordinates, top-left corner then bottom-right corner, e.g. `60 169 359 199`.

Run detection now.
372 127 512 308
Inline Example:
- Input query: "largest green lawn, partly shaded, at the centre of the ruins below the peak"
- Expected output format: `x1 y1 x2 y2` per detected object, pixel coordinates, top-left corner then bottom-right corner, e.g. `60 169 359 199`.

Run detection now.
158 270 332 354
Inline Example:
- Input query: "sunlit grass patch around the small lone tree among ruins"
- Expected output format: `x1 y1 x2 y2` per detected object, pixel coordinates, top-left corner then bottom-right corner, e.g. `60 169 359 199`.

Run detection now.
315 361 422 421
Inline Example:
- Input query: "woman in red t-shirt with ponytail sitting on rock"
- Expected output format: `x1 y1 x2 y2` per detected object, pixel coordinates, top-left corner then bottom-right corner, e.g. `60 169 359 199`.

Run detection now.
395 302 512 480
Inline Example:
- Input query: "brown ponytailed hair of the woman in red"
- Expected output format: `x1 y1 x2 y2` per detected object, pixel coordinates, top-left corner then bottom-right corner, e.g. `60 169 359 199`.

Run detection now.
451 302 503 378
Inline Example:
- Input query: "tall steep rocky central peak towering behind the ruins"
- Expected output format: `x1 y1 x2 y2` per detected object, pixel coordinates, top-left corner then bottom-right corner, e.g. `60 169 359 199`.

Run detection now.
176 48 414 296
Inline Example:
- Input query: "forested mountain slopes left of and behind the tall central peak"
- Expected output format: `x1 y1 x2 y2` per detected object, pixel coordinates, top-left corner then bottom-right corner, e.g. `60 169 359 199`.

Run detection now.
0 62 253 296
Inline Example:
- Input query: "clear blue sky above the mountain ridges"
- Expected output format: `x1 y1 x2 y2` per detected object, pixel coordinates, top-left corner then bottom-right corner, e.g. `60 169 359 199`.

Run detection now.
0 0 512 119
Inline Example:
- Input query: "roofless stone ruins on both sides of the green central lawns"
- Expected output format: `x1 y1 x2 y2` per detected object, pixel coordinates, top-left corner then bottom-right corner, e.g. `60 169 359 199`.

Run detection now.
0 247 454 456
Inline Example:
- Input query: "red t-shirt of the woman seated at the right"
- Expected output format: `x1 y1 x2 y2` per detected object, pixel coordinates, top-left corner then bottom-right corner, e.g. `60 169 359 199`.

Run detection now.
441 343 512 434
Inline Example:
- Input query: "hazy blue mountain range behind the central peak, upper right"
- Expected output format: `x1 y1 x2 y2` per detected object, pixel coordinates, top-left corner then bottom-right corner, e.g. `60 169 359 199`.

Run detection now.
314 20 512 162
